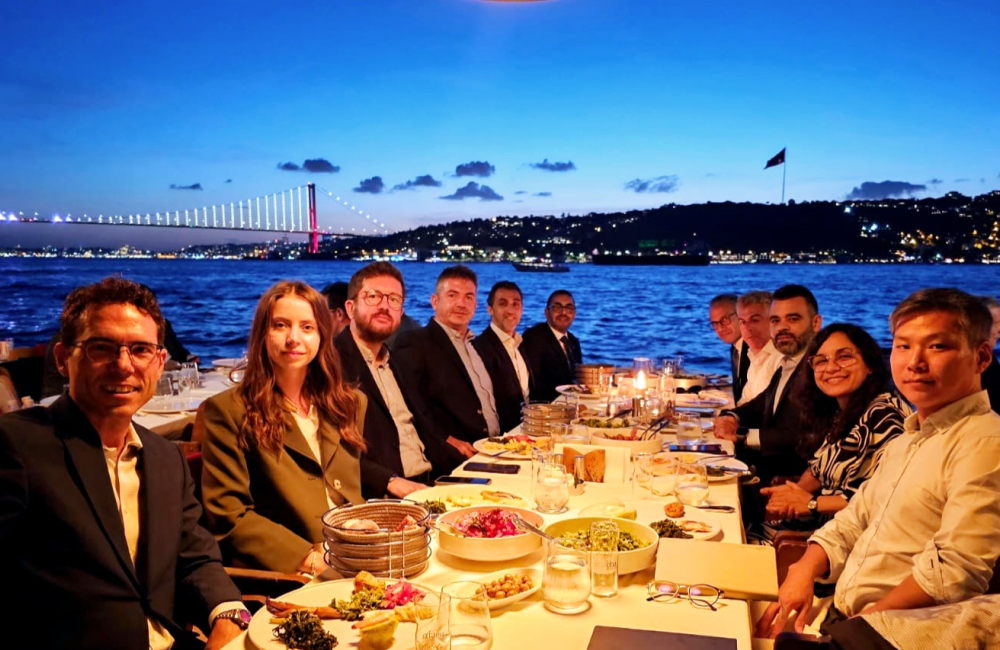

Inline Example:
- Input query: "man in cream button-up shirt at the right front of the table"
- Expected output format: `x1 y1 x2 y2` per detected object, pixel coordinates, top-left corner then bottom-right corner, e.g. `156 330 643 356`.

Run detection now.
757 289 1000 636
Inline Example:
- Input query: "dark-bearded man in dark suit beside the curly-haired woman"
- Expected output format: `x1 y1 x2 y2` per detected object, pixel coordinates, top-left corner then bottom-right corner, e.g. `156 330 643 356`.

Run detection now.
715 284 823 487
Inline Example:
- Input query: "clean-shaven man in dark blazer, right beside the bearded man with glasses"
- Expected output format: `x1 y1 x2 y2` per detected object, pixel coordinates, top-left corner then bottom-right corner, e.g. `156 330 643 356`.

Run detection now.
393 265 500 457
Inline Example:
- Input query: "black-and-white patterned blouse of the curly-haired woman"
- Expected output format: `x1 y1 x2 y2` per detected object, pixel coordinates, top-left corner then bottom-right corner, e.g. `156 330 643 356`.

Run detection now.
809 392 913 500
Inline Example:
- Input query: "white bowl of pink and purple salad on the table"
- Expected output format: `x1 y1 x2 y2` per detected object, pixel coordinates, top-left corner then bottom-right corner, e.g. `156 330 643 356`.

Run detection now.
437 506 545 562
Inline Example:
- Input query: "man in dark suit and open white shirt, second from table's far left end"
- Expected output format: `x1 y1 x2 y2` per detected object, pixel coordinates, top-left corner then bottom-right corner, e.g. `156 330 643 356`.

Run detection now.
472 281 530 432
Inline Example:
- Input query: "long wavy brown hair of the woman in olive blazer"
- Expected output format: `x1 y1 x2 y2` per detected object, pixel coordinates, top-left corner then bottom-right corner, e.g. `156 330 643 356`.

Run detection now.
237 280 366 454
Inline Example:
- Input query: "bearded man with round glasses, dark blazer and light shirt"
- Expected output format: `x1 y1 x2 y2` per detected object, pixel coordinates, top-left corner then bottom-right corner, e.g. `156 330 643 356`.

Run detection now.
334 262 465 498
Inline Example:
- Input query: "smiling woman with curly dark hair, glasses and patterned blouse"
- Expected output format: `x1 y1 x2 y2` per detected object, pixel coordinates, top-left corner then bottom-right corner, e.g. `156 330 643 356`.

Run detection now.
761 323 912 528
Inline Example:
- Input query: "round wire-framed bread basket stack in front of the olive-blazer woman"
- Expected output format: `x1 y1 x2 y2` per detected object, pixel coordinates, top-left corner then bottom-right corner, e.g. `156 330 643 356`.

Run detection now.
323 500 431 578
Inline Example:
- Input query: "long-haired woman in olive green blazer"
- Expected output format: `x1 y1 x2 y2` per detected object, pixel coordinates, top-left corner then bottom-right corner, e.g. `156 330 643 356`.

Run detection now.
202 281 367 575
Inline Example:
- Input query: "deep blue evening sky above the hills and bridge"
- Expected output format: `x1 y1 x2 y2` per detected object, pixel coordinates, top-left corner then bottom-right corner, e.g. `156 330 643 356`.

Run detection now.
0 0 1000 244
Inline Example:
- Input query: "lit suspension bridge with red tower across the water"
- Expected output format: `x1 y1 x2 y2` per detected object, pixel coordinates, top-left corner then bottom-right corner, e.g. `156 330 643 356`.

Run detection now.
0 183 389 253
